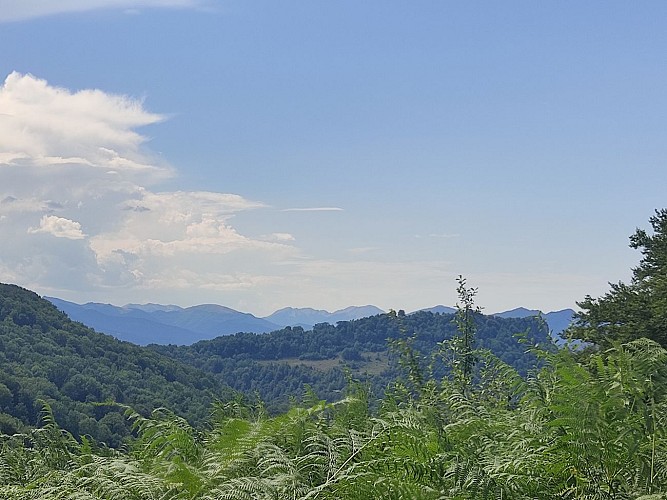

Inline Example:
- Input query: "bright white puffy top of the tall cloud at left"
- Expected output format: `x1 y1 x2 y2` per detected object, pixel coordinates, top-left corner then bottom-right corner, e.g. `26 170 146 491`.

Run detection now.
0 72 169 177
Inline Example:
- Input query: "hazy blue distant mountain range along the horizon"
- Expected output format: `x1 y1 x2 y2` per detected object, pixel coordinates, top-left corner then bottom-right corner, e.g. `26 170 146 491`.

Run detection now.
44 297 574 345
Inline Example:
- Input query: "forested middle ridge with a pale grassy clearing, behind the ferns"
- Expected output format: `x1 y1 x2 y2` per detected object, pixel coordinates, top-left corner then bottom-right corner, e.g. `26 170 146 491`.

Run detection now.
150 311 552 410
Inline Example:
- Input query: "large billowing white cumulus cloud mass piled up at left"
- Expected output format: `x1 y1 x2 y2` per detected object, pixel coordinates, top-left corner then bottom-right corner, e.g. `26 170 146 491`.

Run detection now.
0 73 298 300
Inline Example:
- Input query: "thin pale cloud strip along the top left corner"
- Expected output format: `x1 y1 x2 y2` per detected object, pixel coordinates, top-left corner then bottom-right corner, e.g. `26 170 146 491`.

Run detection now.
0 0 202 22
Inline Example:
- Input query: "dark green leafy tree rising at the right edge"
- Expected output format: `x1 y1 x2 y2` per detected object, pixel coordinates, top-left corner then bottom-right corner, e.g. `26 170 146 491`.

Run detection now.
567 209 667 348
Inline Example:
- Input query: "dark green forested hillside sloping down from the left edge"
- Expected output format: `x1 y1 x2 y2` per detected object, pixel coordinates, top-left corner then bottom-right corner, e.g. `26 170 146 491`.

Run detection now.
0 285 229 446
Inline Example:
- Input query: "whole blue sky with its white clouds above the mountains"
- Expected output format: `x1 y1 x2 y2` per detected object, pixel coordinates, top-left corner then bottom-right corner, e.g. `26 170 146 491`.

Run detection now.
0 0 667 316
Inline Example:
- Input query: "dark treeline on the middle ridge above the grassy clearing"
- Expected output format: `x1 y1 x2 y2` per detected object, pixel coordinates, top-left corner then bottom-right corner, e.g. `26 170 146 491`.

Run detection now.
151 311 551 372
